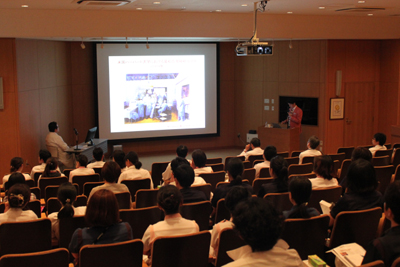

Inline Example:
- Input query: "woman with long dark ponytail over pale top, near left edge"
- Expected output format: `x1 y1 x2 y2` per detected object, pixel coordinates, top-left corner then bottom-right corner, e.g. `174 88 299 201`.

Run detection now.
47 183 86 244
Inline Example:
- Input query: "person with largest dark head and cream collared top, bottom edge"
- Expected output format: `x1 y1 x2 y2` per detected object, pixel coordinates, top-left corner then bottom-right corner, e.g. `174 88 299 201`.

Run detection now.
224 198 304 267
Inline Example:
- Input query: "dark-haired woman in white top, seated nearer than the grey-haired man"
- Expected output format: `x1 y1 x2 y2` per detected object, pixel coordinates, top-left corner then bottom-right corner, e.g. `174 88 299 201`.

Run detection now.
310 155 339 189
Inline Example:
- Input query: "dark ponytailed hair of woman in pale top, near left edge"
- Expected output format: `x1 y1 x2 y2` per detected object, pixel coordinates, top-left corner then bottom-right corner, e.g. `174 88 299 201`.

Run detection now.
57 183 77 219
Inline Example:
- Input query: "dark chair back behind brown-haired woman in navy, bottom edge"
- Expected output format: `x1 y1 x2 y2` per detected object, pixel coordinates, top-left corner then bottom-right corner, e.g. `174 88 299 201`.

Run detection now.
79 239 143 267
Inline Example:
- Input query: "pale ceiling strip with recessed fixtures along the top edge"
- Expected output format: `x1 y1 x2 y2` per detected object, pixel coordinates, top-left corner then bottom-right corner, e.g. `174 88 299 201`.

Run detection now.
0 0 400 16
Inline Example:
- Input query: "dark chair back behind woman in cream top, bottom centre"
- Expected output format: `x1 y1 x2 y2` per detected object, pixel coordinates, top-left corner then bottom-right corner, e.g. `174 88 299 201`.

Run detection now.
152 231 211 267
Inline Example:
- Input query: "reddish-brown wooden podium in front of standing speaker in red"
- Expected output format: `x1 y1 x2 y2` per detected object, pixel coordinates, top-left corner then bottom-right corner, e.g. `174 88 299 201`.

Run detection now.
258 126 300 155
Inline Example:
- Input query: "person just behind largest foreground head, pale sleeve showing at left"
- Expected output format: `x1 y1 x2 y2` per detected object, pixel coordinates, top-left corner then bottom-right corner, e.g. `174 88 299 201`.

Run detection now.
210 186 251 257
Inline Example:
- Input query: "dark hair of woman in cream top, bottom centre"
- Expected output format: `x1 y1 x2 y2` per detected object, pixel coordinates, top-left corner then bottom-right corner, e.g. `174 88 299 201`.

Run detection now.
157 185 183 215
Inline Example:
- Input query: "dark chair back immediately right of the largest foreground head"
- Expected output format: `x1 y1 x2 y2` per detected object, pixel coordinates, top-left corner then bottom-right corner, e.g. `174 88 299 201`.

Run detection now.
281 217 330 260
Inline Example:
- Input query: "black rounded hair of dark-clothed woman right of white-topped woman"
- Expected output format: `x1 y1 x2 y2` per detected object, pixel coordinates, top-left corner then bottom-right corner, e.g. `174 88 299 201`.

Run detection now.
346 159 378 194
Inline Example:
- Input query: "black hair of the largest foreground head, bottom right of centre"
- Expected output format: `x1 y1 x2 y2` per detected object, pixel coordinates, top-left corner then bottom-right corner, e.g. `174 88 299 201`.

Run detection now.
232 198 282 252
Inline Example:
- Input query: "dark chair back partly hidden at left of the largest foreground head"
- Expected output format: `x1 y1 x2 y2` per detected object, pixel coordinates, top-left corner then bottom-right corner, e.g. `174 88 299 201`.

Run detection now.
215 228 246 267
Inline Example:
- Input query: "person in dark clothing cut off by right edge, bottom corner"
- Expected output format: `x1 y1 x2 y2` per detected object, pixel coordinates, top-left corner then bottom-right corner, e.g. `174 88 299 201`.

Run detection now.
363 181 400 266
